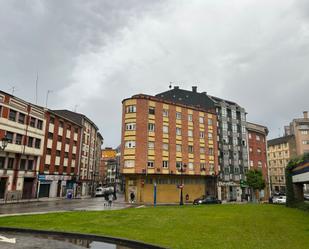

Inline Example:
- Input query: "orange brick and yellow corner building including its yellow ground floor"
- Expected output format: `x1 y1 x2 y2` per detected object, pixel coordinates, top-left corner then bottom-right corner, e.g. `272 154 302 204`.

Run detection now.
121 91 218 203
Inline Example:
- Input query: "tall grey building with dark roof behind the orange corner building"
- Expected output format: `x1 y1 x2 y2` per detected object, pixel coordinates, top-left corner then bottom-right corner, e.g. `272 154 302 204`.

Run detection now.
156 87 249 201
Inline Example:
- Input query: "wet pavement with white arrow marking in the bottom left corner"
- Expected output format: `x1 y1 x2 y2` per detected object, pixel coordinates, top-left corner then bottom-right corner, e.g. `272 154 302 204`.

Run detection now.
0 232 129 249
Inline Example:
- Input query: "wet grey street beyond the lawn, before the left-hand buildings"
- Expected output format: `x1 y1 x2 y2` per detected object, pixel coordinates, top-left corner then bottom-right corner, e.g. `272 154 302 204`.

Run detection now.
0 195 130 217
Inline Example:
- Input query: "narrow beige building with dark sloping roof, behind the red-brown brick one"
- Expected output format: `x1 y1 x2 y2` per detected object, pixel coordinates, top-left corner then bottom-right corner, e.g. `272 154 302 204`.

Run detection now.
53 110 103 196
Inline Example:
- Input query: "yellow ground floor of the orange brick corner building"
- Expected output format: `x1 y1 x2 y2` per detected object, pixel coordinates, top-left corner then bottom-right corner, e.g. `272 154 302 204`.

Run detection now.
124 174 216 204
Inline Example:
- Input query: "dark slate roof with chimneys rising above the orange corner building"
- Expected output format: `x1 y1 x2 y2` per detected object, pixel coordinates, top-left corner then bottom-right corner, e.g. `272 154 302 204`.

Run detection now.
155 87 215 110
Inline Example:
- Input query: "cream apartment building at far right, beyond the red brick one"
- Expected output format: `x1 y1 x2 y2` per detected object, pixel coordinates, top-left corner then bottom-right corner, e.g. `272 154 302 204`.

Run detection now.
267 135 297 193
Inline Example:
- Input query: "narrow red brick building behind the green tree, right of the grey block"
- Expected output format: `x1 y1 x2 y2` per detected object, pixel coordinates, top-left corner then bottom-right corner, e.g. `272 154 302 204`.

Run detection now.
247 122 270 199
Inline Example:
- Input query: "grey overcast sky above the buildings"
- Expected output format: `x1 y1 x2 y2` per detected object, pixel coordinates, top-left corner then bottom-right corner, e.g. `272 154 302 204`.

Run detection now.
0 0 309 146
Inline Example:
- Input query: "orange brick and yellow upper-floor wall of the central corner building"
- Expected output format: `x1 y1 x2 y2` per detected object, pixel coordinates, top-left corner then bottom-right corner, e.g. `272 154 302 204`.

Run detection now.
121 95 218 202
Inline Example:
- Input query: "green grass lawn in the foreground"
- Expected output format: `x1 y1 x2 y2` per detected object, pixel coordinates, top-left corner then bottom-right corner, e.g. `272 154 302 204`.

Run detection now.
0 205 309 249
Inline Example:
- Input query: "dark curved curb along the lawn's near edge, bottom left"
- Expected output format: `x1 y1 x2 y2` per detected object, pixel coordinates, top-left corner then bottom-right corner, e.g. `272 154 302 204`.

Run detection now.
0 227 167 249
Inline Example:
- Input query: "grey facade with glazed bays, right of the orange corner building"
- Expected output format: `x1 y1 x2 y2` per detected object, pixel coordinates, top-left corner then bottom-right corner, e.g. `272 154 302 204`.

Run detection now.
209 96 249 201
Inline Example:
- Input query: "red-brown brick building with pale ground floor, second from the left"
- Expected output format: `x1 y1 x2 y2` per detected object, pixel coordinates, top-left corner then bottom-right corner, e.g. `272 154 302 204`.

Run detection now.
38 110 82 197
